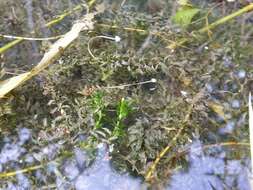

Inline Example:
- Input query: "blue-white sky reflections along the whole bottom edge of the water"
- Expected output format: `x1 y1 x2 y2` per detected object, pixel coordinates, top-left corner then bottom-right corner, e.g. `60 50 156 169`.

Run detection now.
0 128 250 190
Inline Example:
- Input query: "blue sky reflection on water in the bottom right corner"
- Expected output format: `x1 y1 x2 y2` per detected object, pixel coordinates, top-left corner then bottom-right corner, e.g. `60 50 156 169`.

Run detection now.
167 141 250 190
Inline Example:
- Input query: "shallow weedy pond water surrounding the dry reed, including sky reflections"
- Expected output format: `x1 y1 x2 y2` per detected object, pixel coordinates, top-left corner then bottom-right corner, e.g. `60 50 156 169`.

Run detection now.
0 0 253 190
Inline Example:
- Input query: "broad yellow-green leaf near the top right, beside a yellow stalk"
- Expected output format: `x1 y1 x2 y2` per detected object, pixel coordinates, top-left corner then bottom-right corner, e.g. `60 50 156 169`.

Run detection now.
172 7 200 28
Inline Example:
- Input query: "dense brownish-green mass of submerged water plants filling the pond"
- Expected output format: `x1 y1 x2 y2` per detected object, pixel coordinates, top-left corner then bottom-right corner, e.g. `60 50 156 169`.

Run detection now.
0 0 253 189
